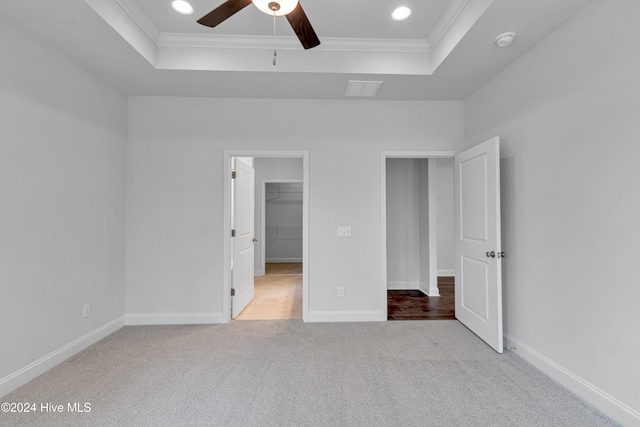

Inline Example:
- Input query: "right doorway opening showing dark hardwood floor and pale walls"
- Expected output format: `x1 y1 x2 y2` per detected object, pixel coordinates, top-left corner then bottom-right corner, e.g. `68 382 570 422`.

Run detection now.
383 153 455 320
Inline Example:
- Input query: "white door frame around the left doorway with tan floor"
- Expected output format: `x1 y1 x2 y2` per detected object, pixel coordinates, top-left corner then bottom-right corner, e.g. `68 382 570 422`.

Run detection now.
221 150 309 323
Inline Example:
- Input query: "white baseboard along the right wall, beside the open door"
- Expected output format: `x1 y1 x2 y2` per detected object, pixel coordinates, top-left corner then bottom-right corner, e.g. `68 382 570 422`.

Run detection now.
504 333 640 426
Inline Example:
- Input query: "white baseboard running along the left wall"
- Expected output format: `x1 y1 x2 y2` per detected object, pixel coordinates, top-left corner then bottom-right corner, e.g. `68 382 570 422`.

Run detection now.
0 316 124 396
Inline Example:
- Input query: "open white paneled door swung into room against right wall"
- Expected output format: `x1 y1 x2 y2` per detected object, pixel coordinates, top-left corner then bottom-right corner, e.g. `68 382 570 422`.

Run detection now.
454 137 503 353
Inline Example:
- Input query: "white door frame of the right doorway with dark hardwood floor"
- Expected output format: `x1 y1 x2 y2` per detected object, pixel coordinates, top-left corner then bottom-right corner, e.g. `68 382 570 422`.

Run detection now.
380 151 459 310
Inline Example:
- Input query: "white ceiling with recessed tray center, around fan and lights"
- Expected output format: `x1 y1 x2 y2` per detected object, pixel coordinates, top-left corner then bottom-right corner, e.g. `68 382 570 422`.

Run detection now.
0 0 592 100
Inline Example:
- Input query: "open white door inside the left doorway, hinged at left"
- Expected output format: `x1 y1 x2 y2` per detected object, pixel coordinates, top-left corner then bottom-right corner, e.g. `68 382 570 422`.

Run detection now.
231 159 255 319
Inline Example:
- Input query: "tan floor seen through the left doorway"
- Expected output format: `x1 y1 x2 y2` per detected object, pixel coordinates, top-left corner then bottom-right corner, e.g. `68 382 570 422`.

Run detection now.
236 263 302 320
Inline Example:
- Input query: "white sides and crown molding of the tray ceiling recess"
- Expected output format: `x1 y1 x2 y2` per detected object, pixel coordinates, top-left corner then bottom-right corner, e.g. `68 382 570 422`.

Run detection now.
85 0 494 75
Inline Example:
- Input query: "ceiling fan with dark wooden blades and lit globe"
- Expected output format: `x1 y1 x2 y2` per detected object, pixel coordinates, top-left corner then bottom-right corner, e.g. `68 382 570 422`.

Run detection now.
198 0 320 49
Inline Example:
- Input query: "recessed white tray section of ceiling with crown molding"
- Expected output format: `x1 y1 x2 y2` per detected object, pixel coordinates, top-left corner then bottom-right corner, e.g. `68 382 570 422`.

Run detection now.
86 0 493 75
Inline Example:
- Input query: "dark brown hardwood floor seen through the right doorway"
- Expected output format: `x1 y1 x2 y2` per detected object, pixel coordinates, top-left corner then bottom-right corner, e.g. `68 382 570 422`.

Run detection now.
387 277 455 320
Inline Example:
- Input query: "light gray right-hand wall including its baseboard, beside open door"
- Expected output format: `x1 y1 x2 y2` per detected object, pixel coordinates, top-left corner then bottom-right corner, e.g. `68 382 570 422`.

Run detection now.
465 0 640 425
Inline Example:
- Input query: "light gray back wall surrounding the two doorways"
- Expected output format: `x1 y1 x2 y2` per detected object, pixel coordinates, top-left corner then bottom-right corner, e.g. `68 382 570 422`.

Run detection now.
126 97 463 321
